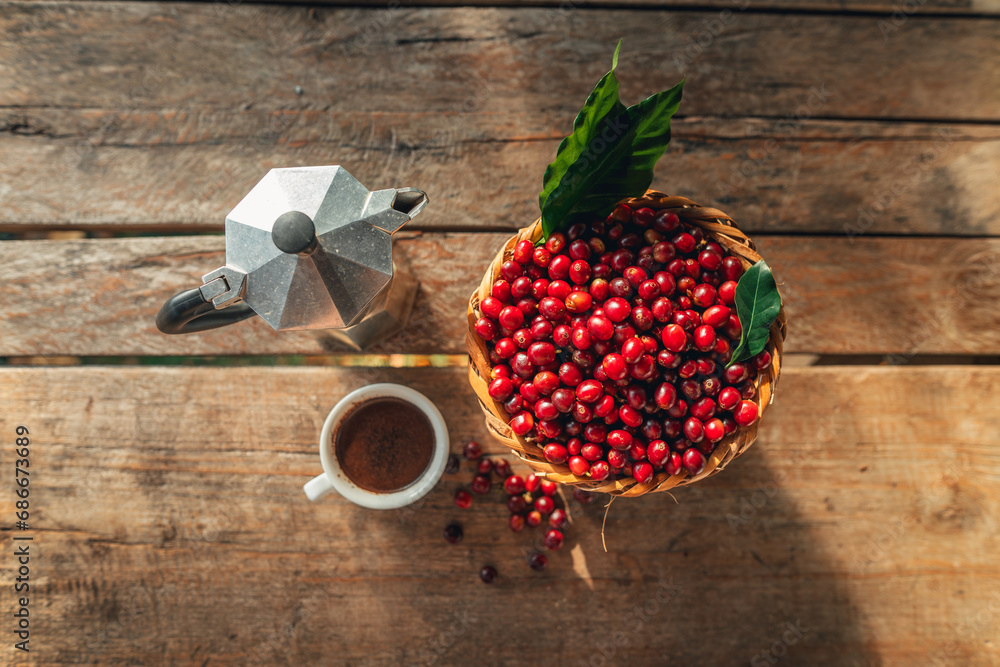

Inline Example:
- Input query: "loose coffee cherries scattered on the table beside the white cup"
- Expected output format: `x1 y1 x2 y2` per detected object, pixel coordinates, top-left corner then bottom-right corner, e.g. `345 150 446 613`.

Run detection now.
444 440 593 583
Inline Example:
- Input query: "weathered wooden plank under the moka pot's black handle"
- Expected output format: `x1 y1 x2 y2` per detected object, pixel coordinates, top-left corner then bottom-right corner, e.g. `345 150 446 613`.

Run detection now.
0 233 1000 363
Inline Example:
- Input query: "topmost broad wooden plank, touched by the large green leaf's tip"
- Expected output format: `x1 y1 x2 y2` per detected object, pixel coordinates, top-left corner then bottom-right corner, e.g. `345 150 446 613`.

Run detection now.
0 3 1000 127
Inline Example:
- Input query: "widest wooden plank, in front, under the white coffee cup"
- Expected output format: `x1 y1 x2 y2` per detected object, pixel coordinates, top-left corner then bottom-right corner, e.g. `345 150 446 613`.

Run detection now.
0 367 1000 665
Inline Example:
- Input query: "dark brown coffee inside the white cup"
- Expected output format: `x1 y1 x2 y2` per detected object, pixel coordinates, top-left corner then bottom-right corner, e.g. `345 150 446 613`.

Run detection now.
333 397 435 493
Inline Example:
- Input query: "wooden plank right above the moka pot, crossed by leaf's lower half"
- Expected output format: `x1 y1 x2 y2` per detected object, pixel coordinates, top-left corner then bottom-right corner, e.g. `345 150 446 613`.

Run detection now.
0 114 1000 235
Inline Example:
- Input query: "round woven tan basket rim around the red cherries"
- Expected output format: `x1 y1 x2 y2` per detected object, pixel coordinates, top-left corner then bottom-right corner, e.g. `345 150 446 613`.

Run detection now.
466 190 786 497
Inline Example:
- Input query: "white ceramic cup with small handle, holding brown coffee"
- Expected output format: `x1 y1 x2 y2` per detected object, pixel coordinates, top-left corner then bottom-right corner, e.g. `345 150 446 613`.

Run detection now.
302 383 449 510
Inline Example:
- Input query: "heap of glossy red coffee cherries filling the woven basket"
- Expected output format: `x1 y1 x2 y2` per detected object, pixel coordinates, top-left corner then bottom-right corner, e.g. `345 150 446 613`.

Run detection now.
474 205 771 484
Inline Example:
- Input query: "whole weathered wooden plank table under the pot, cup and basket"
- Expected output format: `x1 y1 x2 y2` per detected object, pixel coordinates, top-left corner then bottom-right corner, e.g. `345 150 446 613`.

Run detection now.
0 0 1000 667
